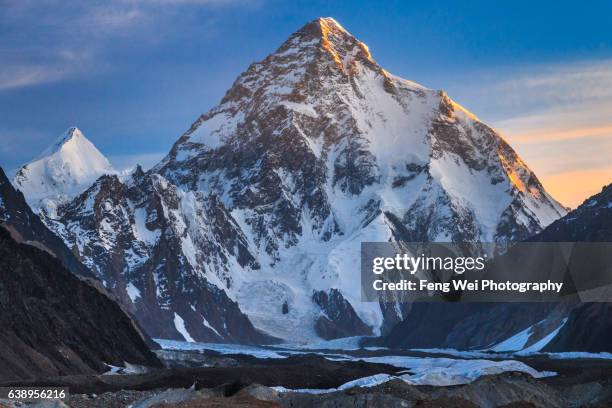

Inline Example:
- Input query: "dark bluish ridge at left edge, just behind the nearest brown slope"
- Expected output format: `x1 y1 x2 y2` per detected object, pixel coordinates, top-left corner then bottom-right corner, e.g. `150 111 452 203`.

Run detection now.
0 168 94 278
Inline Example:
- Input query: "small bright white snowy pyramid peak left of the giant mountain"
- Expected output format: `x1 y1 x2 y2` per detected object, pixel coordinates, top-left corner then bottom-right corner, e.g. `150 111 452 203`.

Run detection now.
13 127 114 209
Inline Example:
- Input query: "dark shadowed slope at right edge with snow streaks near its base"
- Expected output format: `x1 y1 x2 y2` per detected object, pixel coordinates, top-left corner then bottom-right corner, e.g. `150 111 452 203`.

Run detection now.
420 185 612 352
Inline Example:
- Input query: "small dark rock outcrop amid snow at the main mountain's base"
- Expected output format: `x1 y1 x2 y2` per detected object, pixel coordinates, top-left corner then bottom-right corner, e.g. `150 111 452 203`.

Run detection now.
312 289 372 340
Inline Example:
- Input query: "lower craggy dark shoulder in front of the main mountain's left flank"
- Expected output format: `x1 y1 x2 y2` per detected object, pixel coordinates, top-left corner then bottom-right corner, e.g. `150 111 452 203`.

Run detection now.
47 168 274 343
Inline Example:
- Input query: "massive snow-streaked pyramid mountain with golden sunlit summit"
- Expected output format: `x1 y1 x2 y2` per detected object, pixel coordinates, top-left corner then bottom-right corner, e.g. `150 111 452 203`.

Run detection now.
14 18 566 343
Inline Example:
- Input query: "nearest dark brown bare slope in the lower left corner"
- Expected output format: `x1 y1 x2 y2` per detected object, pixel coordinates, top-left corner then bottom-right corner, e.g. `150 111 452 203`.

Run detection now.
0 228 159 381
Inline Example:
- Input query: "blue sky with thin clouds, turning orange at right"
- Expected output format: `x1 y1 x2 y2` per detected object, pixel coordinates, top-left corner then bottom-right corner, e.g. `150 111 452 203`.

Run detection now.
0 0 612 205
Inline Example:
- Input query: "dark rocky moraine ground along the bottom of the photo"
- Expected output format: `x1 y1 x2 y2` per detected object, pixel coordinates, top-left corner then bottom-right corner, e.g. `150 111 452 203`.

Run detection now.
3 355 612 408
